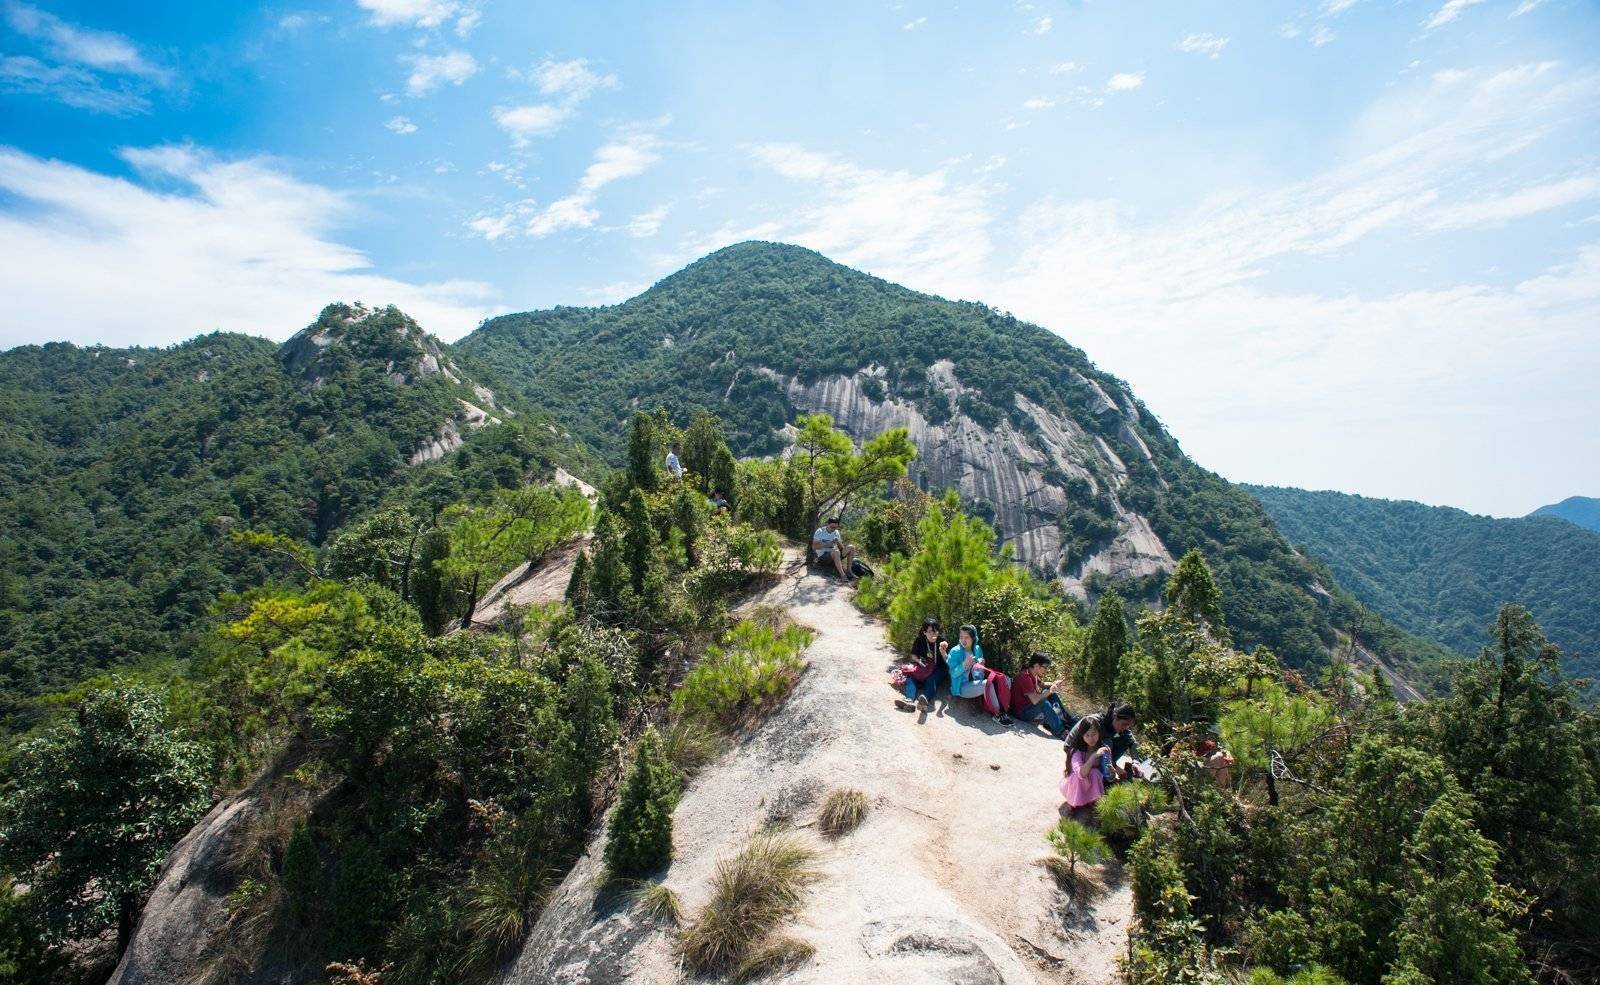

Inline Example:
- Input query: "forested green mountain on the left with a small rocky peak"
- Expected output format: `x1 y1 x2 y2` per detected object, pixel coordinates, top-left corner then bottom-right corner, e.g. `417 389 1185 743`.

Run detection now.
0 305 582 726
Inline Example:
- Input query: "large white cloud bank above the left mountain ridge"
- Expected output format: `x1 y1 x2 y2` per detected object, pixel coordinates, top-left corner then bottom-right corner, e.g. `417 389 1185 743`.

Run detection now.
0 147 498 347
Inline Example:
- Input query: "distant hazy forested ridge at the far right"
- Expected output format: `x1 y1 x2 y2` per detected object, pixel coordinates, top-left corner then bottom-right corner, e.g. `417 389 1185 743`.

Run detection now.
1248 486 1600 678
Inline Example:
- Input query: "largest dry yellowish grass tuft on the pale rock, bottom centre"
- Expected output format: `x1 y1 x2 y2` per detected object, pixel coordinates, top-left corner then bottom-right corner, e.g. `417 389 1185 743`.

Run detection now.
678 831 818 974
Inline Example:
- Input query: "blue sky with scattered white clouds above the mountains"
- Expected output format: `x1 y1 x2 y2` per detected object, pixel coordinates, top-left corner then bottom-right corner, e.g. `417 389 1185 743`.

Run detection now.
0 0 1600 515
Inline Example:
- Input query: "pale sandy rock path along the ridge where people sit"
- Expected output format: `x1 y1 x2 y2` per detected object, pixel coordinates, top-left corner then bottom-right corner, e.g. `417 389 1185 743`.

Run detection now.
506 550 1131 985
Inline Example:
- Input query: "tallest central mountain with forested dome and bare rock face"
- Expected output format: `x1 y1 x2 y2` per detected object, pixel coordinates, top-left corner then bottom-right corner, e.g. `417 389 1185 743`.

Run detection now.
456 243 1443 675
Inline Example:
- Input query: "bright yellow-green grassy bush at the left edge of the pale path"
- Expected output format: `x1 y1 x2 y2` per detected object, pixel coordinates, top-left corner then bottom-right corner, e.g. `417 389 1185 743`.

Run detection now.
672 619 811 731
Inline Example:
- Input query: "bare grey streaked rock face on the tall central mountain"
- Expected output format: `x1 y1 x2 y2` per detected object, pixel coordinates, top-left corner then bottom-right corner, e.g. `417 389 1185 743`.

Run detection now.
763 360 1173 596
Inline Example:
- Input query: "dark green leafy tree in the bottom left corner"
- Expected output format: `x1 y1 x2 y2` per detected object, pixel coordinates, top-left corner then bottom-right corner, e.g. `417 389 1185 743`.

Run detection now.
0 684 211 943
